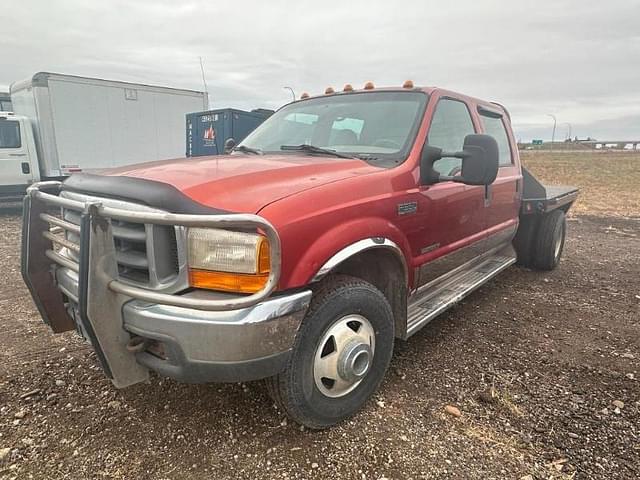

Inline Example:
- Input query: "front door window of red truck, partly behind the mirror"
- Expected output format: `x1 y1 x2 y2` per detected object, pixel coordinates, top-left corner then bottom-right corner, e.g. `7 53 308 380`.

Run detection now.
427 98 475 176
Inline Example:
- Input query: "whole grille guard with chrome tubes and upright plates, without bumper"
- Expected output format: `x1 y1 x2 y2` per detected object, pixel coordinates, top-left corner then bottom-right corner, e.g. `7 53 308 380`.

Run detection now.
21 181 281 387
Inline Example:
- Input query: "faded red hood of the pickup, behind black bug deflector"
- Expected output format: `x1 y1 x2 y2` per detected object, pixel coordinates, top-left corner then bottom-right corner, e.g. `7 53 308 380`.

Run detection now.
105 155 380 213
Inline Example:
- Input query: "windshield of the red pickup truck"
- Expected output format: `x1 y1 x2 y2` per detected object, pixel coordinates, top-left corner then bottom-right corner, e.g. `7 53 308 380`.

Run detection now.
240 92 427 165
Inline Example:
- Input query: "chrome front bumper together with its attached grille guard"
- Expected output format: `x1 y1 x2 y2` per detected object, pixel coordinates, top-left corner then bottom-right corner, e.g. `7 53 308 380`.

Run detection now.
22 182 311 387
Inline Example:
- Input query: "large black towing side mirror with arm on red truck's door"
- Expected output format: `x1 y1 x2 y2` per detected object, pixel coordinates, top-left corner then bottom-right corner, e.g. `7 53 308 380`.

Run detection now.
420 134 499 185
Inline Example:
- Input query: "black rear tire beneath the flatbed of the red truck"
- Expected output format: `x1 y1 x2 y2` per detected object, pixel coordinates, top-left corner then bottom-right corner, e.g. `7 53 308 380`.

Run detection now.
532 210 567 270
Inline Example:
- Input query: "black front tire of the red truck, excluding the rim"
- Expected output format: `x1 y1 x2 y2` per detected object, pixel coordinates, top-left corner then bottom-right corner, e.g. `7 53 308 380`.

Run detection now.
267 275 394 429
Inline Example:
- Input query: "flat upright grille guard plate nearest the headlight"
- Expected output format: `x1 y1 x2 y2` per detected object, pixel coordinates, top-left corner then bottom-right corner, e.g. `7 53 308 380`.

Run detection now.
78 205 149 388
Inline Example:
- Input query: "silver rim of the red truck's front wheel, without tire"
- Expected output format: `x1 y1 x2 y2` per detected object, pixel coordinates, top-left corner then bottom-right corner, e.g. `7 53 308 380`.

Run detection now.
313 315 376 398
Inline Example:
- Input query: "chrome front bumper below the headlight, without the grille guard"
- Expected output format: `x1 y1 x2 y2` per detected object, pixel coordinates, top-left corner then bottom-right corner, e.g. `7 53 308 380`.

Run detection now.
122 290 311 383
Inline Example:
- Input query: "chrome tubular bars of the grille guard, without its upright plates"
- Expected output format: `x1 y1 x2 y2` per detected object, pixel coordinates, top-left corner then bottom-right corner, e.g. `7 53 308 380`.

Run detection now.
23 181 281 311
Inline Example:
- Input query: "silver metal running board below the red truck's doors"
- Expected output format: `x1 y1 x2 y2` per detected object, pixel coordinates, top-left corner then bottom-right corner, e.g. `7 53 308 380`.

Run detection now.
406 246 516 338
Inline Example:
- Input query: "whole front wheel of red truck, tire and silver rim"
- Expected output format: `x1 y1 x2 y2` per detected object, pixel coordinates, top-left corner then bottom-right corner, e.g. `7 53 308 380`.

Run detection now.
267 275 394 429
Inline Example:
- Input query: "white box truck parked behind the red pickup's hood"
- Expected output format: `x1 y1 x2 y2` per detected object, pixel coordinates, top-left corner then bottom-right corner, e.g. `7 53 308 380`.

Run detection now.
0 72 208 199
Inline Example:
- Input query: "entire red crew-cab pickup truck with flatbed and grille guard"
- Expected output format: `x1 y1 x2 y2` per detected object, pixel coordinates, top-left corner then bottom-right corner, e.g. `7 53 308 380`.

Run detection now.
22 82 577 428
